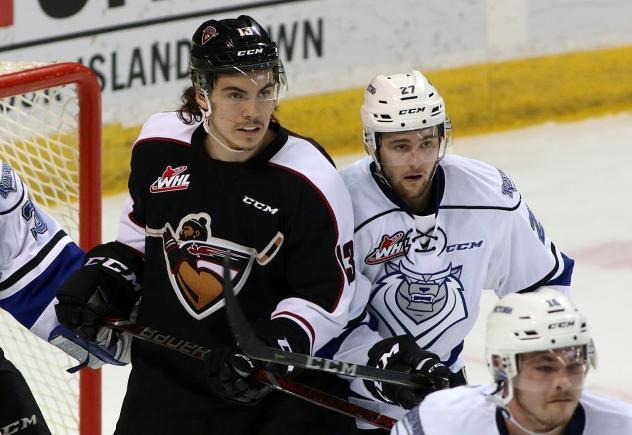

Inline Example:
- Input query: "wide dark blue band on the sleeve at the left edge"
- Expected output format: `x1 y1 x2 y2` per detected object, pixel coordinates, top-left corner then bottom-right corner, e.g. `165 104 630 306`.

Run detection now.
0 242 83 329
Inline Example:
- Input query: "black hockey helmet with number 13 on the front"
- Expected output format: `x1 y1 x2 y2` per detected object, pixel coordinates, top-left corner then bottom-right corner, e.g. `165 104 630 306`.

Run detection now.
189 15 286 94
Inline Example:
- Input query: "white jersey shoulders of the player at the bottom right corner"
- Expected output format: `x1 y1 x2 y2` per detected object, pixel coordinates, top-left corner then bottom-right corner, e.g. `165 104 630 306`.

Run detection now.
391 385 632 435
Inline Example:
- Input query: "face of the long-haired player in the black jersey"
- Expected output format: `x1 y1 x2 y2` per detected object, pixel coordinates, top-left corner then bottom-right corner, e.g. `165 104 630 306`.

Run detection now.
198 70 278 151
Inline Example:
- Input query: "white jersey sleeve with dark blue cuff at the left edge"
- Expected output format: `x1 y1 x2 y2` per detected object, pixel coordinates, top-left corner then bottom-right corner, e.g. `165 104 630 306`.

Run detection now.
0 161 83 340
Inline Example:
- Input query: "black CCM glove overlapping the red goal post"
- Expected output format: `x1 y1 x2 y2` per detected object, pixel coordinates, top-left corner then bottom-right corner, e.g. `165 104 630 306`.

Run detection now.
55 242 143 341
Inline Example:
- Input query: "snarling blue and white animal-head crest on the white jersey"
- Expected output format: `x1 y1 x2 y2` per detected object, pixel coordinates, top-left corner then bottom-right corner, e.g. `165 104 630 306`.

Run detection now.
370 262 468 347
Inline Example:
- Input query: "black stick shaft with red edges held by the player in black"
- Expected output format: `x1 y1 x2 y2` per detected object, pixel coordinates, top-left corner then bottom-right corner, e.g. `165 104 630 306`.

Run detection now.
104 319 395 429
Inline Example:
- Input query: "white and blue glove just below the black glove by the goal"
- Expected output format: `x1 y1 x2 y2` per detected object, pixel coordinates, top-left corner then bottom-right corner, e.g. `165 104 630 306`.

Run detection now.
48 325 132 373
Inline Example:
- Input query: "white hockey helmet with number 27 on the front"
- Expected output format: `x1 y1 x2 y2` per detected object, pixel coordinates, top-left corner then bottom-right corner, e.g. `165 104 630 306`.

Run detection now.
360 70 452 170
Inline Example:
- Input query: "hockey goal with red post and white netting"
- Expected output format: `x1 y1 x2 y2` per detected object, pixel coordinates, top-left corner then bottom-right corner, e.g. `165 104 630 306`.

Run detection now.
0 61 101 435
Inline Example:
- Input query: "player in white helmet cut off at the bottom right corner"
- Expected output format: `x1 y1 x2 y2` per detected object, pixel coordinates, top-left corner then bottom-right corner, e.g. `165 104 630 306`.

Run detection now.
391 288 632 435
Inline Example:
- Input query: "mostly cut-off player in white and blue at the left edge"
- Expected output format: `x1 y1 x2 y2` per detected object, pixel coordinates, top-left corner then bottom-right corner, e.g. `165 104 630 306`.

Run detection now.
0 161 125 434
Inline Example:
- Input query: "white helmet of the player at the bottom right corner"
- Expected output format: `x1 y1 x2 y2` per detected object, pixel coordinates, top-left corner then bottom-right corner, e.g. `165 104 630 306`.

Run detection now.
485 287 596 405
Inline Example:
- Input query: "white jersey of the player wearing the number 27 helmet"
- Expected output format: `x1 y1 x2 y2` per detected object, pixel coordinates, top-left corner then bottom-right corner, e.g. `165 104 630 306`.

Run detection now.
327 155 573 428
